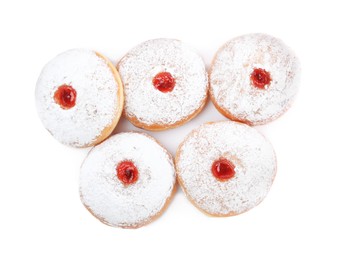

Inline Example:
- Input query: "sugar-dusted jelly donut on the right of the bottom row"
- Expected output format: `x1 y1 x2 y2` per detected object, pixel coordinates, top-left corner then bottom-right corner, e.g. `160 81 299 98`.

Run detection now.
175 121 277 216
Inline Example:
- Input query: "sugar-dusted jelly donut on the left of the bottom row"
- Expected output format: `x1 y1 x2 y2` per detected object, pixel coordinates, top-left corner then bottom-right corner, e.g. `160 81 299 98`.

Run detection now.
80 132 176 228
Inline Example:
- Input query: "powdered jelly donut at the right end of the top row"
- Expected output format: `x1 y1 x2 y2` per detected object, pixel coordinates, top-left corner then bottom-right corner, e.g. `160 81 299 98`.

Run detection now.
209 34 300 125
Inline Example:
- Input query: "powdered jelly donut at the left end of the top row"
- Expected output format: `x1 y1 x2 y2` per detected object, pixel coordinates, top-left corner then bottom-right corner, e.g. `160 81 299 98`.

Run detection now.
35 49 123 147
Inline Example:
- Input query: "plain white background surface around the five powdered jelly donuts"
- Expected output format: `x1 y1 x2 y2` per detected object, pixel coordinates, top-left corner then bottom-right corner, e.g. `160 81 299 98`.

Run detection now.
0 0 339 260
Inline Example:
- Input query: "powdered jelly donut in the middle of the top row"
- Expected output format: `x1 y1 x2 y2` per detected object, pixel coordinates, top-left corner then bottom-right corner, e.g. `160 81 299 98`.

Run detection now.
118 39 208 131
